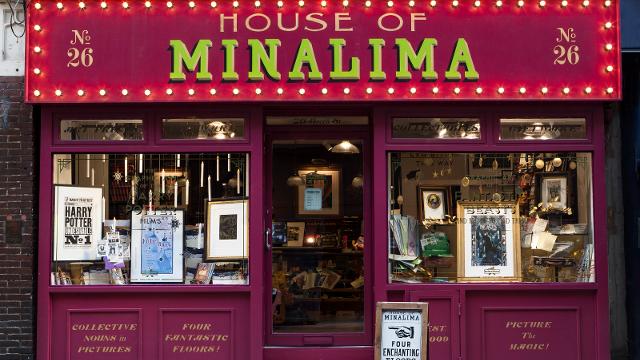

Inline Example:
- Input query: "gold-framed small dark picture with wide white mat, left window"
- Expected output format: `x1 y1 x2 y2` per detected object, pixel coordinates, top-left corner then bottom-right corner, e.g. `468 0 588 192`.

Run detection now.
205 199 249 260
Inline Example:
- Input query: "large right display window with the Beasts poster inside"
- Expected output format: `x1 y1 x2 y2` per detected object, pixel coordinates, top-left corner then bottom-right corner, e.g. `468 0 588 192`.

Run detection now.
388 152 595 283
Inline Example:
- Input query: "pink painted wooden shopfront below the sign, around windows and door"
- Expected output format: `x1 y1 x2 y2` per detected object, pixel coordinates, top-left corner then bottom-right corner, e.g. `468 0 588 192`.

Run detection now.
37 103 609 360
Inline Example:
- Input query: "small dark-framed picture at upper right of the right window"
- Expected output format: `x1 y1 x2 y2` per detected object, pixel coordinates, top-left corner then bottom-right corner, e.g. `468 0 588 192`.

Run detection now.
536 172 578 222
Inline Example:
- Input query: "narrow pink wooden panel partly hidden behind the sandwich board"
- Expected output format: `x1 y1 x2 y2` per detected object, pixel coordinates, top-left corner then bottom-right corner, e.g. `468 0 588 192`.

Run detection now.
409 290 460 360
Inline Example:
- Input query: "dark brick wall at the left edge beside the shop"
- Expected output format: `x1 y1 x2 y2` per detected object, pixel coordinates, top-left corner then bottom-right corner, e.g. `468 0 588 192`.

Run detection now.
0 77 37 360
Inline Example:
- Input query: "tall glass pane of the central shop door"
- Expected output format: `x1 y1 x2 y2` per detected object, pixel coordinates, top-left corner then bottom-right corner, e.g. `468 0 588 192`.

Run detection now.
271 140 365 333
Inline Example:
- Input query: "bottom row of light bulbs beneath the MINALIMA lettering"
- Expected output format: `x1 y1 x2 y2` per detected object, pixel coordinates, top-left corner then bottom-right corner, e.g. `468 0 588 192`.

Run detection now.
33 86 615 97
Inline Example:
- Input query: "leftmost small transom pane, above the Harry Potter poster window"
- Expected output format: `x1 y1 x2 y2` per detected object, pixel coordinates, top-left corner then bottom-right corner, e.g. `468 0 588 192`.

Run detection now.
60 119 144 141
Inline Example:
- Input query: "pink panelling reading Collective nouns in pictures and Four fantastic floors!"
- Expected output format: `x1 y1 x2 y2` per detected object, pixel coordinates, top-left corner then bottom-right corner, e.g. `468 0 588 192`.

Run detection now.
50 289 248 360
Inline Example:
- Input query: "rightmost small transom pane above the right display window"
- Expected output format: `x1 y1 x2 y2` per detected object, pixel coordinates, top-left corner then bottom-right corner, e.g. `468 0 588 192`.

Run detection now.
500 118 587 140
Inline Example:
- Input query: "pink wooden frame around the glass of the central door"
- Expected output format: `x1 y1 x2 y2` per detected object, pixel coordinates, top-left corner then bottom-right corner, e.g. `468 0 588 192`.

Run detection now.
263 123 374 346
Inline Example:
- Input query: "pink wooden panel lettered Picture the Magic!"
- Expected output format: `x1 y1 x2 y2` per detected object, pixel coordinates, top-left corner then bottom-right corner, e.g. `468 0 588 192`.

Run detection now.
463 291 598 360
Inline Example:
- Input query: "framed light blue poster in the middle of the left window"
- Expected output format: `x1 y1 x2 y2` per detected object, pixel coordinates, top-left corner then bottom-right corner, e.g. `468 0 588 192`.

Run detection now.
131 210 184 283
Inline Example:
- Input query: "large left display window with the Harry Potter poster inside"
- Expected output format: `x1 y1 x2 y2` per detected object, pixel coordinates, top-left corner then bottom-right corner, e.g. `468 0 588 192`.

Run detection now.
51 153 249 285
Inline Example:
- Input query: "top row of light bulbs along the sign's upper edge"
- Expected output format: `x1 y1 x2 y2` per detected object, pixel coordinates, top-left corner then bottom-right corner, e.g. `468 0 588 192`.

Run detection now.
34 0 612 10
